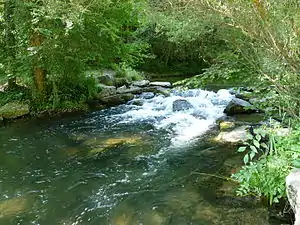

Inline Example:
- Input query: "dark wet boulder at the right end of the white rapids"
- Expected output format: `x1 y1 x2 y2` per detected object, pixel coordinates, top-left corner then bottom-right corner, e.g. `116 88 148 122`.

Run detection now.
224 98 258 116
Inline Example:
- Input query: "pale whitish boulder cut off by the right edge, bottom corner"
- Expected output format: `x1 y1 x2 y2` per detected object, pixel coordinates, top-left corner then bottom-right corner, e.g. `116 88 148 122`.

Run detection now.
286 169 300 225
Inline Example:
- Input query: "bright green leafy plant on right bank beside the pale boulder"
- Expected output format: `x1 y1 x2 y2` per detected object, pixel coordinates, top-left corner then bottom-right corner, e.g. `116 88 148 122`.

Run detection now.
232 123 300 204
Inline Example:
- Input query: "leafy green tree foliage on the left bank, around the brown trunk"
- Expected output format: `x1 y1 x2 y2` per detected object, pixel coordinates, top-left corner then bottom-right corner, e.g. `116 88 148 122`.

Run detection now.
0 0 148 108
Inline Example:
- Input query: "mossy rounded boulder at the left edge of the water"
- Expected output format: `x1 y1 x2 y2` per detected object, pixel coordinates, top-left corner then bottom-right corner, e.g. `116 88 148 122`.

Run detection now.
0 102 30 119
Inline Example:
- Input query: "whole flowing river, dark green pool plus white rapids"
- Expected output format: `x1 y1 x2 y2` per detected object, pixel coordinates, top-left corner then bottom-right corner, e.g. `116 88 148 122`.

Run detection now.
0 90 271 225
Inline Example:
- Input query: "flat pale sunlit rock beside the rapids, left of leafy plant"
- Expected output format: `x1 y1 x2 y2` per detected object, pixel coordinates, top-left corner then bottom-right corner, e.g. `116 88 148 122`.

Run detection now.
214 126 249 144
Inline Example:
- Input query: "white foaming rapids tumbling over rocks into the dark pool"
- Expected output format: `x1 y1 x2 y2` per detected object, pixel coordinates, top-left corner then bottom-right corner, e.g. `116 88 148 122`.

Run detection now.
113 89 233 147
